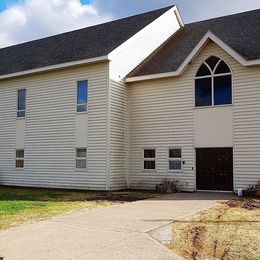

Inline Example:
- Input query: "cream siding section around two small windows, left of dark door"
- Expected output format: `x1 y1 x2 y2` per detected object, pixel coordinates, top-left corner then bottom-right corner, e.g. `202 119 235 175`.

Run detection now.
129 73 194 191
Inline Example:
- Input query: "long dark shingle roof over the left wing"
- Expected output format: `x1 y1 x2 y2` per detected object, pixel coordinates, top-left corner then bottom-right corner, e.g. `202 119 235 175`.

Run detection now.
0 6 175 75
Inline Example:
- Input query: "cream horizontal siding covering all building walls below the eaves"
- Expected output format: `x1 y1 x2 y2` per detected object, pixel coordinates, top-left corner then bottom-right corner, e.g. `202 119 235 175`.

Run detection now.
0 40 260 191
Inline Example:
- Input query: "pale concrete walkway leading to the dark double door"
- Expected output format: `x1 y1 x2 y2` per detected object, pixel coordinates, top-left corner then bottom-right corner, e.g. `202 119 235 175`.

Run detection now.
0 193 231 260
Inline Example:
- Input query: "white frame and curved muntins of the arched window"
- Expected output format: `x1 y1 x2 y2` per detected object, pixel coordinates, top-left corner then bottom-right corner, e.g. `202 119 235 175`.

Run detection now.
193 55 234 109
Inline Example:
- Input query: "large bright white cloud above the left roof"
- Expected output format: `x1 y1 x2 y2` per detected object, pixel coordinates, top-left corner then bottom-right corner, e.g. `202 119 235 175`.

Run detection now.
0 0 112 47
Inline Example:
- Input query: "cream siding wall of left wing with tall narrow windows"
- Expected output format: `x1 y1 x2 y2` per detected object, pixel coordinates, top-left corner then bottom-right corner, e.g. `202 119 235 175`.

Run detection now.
0 63 108 190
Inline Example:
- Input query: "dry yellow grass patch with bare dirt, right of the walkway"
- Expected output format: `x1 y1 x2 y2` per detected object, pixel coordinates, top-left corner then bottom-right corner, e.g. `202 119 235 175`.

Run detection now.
169 198 260 260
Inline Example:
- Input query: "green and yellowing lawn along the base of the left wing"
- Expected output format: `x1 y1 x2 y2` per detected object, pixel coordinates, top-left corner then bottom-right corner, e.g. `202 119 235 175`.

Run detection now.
0 186 154 230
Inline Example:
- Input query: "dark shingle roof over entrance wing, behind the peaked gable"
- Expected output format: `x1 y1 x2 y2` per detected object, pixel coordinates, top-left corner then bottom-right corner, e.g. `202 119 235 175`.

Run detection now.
128 9 260 77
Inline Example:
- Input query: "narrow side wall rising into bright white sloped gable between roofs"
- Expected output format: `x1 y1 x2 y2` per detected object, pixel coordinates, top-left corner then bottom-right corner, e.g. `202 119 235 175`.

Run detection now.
108 7 180 189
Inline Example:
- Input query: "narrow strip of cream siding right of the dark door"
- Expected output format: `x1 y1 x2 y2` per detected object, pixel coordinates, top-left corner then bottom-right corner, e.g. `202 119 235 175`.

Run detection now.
232 62 260 190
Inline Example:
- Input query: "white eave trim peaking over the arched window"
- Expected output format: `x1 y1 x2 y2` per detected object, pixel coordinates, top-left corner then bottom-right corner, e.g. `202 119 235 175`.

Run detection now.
125 31 260 82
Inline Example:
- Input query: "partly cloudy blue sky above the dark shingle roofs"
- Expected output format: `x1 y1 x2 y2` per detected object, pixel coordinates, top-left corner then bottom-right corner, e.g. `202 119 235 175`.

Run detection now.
0 0 260 48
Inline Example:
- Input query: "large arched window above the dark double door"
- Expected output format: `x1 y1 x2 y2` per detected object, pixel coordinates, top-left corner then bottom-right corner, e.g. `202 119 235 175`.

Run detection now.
195 56 232 107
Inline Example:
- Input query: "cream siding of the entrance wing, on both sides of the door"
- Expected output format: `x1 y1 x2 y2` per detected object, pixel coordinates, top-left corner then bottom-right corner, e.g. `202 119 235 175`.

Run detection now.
129 40 260 191
